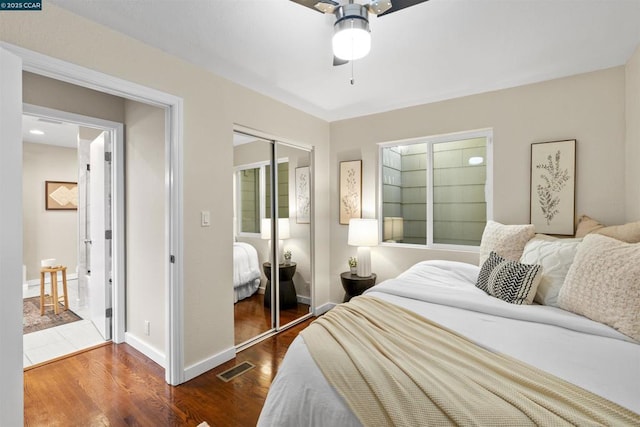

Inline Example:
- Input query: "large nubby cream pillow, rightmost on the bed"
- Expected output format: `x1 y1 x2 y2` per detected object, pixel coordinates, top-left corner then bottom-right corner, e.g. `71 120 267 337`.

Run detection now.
558 234 640 341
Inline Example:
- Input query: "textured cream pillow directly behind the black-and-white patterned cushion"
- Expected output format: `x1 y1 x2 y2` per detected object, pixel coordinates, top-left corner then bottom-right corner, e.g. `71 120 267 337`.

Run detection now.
479 220 535 267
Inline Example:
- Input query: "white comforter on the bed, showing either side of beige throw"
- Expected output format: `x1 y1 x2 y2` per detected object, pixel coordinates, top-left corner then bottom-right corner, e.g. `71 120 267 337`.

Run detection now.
258 261 640 426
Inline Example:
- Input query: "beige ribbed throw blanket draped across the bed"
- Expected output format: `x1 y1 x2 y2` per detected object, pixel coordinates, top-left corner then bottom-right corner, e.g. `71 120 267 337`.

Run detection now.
302 296 640 427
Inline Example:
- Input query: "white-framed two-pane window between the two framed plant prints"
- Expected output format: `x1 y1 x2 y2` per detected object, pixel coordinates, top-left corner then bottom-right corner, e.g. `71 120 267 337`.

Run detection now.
379 130 492 251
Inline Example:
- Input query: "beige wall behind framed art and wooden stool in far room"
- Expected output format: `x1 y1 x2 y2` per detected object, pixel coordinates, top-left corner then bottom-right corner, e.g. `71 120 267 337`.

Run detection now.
22 142 78 280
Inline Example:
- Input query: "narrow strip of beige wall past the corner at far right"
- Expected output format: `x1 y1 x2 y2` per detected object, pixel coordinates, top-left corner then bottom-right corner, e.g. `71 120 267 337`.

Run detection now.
625 45 640 221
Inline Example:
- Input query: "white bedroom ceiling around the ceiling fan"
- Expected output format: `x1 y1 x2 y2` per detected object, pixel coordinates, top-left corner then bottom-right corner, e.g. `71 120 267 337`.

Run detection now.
50 0 640 121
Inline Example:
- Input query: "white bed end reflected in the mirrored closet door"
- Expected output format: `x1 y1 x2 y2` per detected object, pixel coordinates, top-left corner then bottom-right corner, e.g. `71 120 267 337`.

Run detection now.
233 242 260 303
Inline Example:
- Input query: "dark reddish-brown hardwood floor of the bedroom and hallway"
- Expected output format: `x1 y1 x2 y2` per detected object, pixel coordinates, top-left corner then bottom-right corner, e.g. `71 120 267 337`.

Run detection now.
24 320 311 427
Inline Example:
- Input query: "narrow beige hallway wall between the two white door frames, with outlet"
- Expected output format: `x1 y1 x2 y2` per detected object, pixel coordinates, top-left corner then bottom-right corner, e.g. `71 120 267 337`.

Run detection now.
124 100 167 354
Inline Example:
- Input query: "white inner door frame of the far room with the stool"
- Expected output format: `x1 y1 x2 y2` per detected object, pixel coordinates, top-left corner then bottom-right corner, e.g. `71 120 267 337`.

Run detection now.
22 103 126 344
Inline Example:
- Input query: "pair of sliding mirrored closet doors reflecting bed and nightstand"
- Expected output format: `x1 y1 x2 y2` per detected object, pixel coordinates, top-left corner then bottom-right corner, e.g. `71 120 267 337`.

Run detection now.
233 132 312 347
